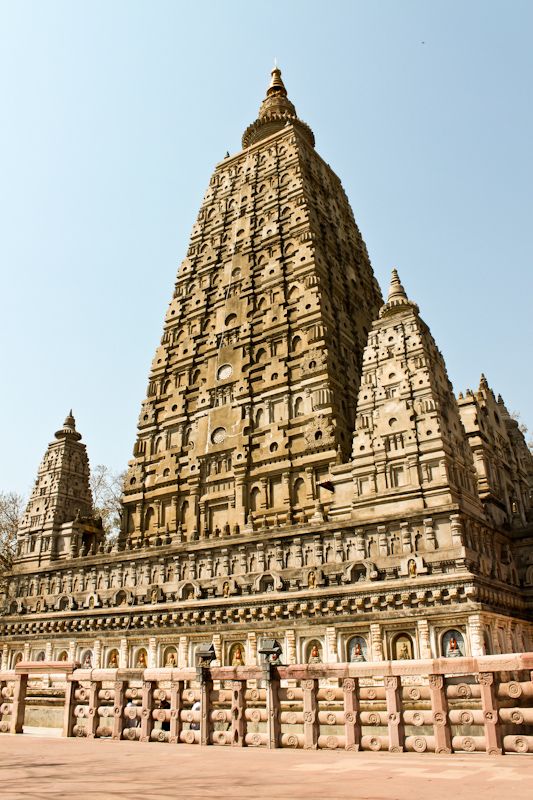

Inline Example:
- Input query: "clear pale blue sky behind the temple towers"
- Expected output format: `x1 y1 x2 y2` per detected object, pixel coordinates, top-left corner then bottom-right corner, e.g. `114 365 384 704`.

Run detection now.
0 0 533 500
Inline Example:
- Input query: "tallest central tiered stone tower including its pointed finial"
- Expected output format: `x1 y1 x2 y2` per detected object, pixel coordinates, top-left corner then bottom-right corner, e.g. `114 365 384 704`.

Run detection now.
122 68 382 545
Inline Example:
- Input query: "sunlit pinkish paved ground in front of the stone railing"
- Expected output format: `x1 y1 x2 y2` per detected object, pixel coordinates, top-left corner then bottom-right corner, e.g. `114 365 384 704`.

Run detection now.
0 729 533 800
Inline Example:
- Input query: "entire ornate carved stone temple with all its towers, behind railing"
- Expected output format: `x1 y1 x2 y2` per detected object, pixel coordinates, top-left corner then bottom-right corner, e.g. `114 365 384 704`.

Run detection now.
0 68 533 669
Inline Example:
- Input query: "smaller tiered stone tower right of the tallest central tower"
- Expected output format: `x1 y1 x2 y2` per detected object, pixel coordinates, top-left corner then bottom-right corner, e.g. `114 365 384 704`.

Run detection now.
353 270 483 518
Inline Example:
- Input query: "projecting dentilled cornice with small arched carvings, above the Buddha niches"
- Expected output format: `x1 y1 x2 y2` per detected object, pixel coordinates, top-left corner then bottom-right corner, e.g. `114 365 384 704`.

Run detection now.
0 582 524 637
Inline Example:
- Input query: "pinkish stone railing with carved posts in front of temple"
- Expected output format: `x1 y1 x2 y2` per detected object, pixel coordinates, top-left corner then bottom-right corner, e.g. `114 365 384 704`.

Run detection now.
0 653 533 754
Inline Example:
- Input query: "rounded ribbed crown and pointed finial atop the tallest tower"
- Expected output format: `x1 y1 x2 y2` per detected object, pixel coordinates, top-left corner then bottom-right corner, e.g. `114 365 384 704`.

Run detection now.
242 64 315 147
